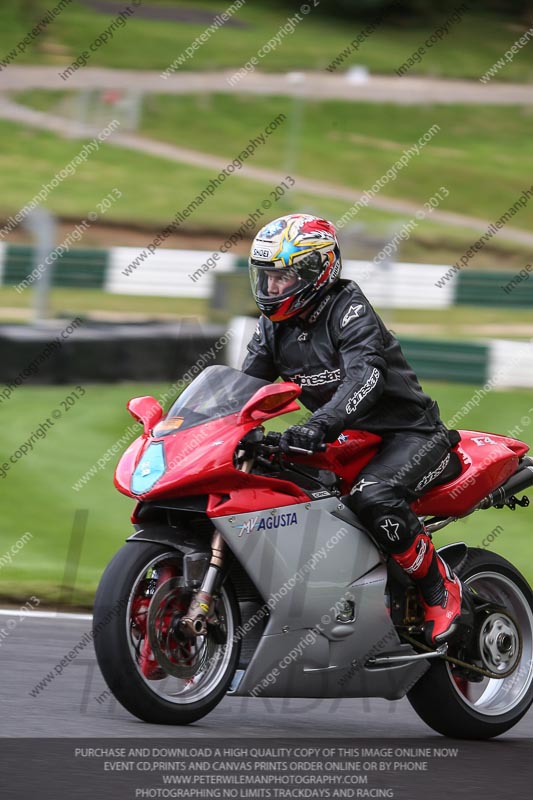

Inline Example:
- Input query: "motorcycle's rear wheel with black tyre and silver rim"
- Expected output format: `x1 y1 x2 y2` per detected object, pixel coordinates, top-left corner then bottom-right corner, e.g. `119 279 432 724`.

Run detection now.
407 548 533 739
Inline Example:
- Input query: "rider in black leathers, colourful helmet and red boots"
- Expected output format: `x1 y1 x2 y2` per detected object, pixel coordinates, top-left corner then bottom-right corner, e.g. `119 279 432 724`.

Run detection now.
242 214 462 645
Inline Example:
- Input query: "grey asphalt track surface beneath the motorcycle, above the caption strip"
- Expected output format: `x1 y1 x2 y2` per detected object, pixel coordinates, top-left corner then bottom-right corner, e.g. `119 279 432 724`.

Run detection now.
0 612 533 740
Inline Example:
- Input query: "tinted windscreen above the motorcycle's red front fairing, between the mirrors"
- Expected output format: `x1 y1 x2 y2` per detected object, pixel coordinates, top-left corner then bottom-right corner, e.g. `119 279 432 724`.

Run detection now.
153 366 269 436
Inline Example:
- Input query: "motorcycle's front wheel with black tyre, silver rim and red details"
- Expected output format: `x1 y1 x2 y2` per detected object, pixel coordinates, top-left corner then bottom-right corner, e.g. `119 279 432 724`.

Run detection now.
93 542 240 725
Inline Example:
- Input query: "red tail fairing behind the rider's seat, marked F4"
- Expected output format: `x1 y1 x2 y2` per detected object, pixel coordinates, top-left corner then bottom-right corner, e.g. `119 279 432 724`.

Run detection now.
412 431 529 517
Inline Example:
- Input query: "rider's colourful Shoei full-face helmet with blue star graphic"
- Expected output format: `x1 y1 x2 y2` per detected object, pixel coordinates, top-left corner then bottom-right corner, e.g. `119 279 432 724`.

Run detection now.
248 214 341 322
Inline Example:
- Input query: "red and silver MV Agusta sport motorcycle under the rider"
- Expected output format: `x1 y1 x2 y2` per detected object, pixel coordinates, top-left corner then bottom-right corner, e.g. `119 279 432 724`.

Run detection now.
93 366 533 739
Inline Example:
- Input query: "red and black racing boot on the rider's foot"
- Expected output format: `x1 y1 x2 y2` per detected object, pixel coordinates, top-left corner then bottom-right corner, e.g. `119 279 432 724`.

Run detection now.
391 533 462 646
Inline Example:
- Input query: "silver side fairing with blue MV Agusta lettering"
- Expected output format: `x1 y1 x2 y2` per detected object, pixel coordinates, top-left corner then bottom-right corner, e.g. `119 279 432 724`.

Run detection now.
212 497 429 699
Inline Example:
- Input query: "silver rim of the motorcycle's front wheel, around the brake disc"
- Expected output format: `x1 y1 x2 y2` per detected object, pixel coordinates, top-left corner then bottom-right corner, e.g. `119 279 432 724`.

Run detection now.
126 551 234 705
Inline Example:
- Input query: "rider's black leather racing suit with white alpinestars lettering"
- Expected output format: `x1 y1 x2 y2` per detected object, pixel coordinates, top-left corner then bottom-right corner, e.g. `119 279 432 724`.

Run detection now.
242 280 450 552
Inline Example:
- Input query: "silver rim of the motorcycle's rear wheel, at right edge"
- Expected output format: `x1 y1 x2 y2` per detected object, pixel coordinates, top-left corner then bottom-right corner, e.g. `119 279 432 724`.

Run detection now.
446 571 533 717
